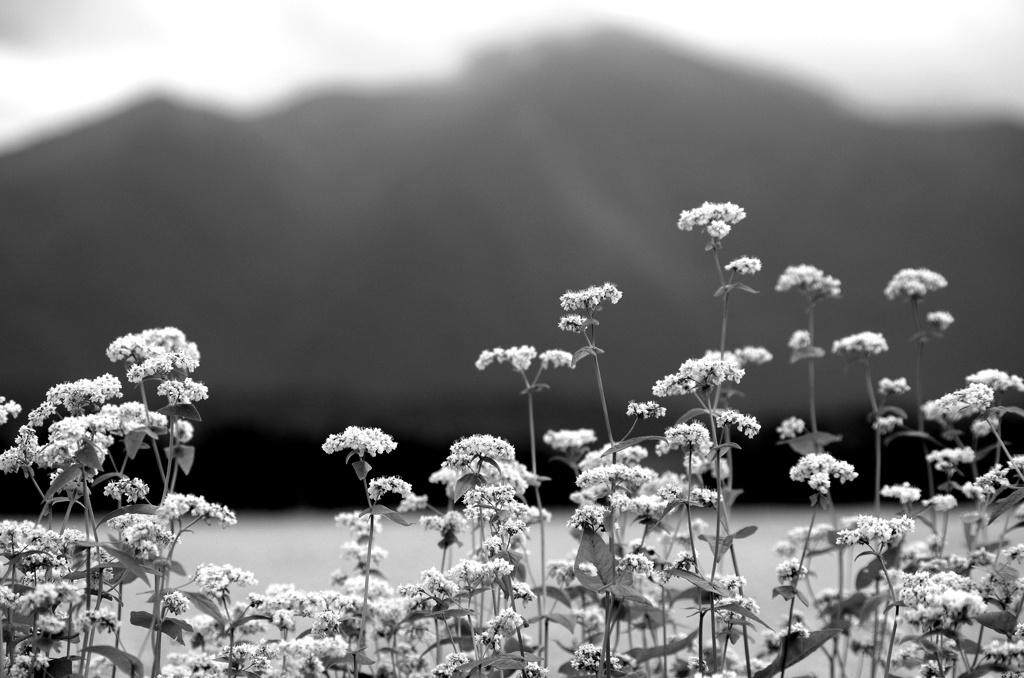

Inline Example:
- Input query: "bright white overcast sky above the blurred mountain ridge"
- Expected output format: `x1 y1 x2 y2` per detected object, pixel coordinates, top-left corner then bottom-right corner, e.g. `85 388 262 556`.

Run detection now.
0 0 1024 151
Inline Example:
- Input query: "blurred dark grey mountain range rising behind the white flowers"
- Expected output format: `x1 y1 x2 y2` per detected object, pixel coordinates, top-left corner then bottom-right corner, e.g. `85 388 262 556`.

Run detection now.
0 31 1024 481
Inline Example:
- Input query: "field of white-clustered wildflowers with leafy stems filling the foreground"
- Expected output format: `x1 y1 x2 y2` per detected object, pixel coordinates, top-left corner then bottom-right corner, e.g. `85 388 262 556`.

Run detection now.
0 203 1024 678
